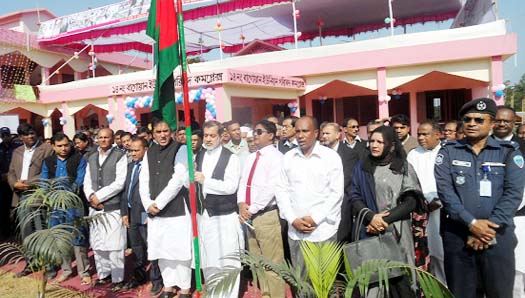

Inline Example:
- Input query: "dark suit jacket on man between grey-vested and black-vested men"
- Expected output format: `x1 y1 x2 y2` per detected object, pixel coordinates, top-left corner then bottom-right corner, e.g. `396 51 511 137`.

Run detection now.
120 162 146 224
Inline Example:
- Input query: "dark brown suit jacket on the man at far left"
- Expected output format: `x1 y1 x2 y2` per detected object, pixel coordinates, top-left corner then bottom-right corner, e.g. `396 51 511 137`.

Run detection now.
7 141 54 207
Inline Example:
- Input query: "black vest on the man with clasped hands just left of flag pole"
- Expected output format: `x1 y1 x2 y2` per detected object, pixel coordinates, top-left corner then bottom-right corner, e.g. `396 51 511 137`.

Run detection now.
148 141 189 217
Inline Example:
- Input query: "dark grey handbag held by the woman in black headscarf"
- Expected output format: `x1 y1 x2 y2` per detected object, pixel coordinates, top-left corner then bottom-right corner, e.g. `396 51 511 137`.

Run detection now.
343 208 407 283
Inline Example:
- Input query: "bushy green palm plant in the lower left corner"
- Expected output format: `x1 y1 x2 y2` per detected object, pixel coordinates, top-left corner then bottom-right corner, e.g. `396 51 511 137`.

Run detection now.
0 178 106 298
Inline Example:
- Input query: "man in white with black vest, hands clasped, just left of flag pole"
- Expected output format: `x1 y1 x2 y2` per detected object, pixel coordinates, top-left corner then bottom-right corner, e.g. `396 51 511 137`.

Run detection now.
139 121 192 298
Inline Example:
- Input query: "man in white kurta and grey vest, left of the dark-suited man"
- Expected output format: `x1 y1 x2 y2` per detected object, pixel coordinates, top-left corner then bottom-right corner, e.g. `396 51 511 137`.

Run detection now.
84 128 128 290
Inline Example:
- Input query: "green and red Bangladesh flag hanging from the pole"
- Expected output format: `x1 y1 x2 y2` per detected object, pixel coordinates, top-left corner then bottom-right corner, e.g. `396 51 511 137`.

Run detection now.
146 0 180 129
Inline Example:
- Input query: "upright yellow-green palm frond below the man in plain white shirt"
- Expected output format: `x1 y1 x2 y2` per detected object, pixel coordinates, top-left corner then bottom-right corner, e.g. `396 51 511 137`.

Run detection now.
300 241 342 298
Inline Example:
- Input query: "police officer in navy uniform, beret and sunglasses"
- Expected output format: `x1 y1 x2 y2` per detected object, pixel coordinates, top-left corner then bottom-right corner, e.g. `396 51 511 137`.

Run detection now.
435 98 525 298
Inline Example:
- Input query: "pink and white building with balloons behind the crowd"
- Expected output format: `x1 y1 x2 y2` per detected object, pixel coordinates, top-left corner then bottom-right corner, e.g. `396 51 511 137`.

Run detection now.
0 0 517 135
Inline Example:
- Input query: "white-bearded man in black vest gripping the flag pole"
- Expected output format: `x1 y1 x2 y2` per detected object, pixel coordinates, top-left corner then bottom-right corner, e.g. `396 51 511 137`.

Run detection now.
195 121 244 298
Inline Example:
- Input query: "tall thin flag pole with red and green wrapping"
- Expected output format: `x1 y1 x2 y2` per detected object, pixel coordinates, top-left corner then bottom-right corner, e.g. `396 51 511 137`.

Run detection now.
177 0 202 297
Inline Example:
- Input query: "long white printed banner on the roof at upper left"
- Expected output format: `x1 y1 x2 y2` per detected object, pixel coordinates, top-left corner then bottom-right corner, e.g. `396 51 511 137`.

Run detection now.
38 0 214 40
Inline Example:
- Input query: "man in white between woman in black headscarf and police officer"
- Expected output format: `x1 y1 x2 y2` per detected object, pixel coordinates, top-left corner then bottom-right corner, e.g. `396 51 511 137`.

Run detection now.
407 120 446 283
